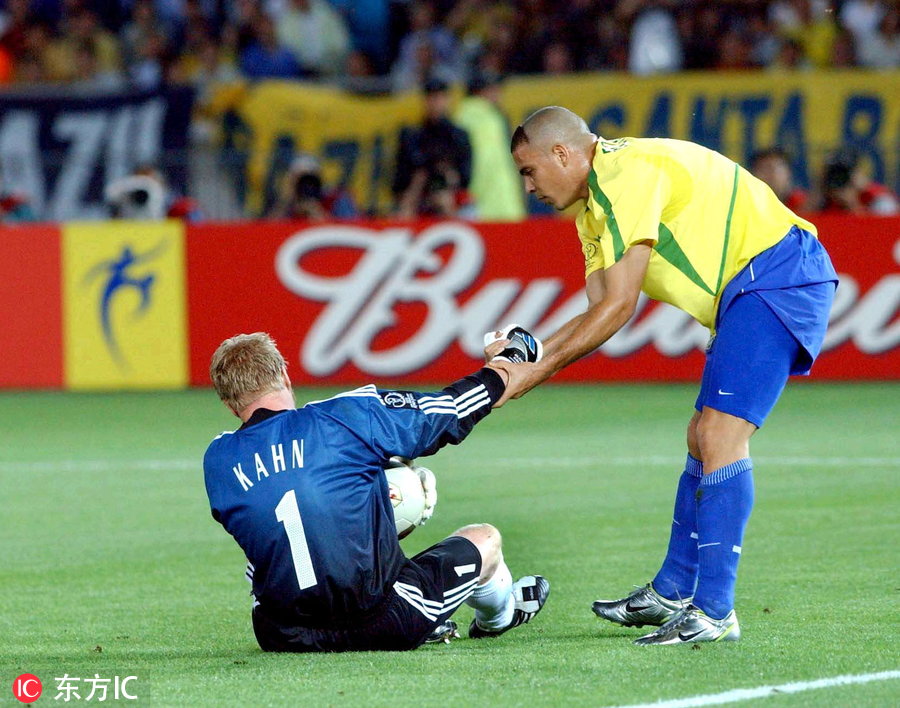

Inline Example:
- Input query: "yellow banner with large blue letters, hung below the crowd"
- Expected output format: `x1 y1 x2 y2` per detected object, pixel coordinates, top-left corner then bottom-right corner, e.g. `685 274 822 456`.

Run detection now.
221 70 900 213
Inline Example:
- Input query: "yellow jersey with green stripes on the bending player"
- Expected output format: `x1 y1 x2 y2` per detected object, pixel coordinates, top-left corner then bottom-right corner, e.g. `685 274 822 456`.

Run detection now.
576 138 816 329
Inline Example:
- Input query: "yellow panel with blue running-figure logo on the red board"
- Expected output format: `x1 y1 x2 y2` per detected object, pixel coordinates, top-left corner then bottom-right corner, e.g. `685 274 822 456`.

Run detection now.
62 221 187 389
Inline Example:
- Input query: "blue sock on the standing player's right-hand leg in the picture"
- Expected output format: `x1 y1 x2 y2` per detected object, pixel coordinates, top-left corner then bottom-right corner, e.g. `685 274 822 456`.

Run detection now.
694 457 753 619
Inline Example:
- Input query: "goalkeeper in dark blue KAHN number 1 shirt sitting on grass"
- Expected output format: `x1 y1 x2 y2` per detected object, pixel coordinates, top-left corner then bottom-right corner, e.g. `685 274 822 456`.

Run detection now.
203 332 550 651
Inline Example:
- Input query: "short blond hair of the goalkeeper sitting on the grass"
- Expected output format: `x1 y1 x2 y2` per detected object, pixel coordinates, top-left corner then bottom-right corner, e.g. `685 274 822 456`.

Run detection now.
209 332 287 412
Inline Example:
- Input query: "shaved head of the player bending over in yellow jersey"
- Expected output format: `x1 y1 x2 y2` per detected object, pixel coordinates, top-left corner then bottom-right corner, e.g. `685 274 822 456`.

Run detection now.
510 106 597 210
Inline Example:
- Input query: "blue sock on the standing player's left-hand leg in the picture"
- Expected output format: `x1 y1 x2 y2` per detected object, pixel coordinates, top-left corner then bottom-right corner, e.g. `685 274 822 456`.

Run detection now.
653 454 703 600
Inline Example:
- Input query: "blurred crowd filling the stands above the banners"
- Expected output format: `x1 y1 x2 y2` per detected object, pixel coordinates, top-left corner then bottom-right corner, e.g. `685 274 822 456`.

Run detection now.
0 0 900 91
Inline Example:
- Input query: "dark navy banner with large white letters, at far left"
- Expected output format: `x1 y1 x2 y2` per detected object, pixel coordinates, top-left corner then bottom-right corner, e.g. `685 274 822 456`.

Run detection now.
0 86 194 221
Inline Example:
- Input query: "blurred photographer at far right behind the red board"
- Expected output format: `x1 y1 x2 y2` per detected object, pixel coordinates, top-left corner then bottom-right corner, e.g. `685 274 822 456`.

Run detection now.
822 148 900 216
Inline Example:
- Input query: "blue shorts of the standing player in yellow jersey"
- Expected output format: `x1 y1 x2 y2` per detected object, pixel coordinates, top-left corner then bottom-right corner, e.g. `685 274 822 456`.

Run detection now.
694 229 837 428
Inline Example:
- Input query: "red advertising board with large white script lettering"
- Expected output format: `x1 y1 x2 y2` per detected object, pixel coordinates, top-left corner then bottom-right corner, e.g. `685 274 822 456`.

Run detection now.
187 216 900 385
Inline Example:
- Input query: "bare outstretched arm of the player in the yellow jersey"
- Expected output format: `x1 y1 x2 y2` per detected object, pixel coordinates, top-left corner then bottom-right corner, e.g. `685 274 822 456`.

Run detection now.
494 241 653 408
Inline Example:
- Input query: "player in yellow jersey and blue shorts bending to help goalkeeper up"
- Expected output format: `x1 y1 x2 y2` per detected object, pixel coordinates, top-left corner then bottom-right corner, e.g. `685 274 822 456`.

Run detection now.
487 106 837 644
